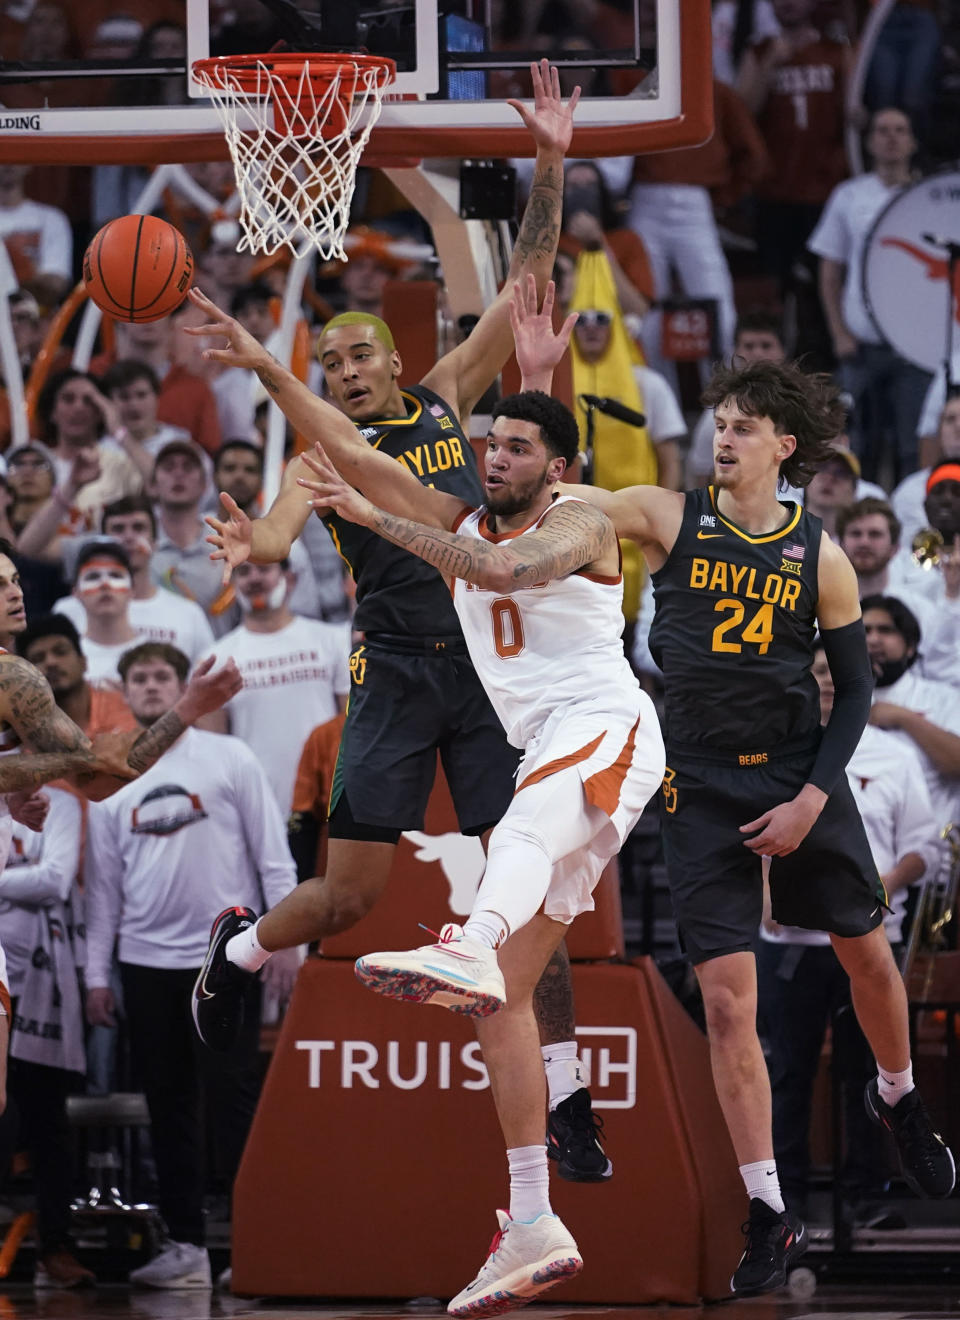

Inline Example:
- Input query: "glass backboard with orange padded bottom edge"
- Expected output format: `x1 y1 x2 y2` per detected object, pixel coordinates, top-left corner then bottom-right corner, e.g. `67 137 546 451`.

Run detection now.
0 0 713 164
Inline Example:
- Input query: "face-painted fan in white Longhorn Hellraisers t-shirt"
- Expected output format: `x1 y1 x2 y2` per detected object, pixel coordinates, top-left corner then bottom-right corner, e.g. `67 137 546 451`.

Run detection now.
196 561 350 813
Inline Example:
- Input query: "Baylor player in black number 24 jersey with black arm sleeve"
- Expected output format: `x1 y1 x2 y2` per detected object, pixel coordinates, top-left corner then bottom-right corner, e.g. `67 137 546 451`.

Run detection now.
518 327 955 1294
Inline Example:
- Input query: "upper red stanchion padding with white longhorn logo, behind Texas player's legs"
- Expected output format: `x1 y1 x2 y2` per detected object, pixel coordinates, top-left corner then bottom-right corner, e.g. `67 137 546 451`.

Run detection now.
321 767 623 958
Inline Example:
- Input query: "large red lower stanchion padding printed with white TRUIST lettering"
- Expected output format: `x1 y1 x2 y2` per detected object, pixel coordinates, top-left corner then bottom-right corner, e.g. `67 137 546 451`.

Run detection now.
232 958 746 1304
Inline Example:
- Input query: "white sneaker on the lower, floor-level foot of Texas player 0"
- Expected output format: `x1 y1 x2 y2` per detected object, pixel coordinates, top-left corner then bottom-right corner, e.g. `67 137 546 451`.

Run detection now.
446 1210 584 1316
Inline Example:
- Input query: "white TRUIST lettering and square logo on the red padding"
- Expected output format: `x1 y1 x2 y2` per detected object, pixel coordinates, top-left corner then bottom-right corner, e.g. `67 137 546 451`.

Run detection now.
293 1027 636 1109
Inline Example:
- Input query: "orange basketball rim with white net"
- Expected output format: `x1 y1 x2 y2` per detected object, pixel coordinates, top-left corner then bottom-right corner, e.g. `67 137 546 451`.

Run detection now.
193 53 396 261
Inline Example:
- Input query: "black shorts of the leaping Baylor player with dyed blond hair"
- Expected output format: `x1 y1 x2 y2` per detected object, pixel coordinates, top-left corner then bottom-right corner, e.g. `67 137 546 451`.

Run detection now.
330 639 520 842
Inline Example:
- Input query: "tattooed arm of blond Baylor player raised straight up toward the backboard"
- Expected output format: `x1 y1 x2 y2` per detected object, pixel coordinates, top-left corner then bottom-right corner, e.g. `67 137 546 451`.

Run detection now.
424 59 580 418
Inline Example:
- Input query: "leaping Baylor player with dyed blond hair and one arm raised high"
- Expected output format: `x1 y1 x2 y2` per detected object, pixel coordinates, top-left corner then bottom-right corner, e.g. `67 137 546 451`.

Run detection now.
184 69 611 1181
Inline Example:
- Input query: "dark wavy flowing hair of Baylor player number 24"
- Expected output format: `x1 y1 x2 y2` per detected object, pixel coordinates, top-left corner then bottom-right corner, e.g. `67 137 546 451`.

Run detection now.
703 362 846 486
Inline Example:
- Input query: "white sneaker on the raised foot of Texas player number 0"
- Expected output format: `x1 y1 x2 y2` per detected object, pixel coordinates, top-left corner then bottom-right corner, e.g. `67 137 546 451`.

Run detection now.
354 923 507 1018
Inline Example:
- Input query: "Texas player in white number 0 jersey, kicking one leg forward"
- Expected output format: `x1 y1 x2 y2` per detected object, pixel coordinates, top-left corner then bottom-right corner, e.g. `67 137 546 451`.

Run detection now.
293 391 664 1316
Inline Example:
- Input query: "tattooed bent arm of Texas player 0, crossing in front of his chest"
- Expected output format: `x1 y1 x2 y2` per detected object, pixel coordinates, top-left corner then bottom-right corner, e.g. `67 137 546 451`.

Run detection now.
301 451 617 595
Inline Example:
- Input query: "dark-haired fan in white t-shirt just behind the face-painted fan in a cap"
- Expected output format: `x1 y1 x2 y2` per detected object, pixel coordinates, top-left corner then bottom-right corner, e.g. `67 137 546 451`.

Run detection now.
54 495 214 664
